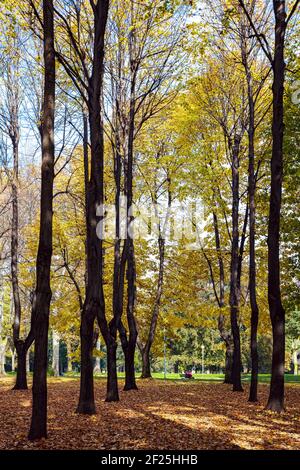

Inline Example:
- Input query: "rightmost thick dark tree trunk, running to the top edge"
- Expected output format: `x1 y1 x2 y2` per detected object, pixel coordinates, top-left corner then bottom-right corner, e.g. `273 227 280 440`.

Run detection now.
267 0 286 412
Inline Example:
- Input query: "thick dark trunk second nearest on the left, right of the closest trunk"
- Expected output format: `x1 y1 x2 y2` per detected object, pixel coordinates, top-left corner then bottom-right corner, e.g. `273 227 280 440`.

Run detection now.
77 0 109 414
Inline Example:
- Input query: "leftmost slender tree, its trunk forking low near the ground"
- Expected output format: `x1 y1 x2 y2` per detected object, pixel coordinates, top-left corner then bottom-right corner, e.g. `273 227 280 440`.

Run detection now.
0 9 33 390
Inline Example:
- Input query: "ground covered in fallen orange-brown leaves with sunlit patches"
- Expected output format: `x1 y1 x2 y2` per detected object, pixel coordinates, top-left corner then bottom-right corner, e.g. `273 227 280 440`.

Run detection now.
0 377 300 450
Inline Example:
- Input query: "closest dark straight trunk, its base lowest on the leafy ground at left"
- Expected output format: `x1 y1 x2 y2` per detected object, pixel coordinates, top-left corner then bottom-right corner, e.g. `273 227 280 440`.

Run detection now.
28 0 55 440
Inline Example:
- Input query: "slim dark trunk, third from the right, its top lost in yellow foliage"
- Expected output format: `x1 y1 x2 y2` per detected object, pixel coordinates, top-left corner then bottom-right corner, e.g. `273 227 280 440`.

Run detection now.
229 136 243 391
